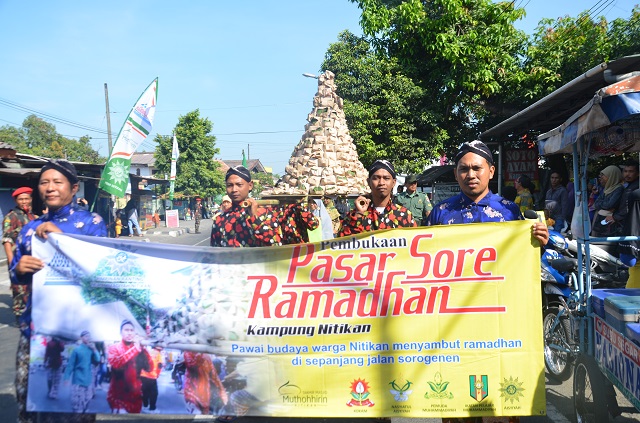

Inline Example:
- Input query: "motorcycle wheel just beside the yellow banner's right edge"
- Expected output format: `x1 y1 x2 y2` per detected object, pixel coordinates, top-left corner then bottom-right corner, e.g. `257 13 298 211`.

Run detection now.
542 307 573 382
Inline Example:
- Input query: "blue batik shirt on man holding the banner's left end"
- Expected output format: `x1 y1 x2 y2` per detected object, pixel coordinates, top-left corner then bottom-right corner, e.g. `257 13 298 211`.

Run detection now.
9 202 107 336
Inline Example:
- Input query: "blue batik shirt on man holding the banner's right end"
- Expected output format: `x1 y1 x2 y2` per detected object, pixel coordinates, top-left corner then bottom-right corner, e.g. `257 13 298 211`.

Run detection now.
429 191 524 225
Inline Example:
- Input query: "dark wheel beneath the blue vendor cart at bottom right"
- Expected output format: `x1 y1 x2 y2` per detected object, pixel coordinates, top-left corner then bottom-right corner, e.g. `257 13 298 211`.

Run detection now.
573 355 609 423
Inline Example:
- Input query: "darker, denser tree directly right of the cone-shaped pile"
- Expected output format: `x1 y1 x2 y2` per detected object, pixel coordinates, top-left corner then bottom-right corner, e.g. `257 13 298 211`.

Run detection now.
322 31 442 172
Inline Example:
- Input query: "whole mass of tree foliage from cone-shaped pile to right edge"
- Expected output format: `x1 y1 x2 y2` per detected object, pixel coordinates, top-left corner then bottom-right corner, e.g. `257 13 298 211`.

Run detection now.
322 0 640 172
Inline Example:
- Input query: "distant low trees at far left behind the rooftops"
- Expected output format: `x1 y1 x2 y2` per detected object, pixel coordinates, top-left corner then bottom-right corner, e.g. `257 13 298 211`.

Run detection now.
0 115 105 164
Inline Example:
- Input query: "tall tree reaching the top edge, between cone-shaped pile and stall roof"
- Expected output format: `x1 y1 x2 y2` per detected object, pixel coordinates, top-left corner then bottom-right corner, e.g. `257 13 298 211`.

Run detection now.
332 0 526 163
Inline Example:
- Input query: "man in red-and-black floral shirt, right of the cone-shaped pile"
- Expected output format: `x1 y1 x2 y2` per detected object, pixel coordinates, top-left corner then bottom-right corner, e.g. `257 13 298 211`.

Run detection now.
338 160 417 236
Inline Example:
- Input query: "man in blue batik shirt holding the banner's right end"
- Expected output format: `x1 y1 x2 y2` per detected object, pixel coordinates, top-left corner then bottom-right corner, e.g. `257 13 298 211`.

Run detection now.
429 141 549 245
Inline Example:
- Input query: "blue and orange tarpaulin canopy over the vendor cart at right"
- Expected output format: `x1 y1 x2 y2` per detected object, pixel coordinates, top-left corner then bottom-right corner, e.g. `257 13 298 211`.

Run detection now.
538 75 640 157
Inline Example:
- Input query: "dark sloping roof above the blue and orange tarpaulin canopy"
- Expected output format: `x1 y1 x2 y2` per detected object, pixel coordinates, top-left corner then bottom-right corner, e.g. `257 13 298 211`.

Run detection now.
480 55 640 142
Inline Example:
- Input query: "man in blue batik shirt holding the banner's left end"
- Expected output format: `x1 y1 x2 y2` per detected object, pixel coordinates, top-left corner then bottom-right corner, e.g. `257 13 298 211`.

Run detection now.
9 160 107 422
